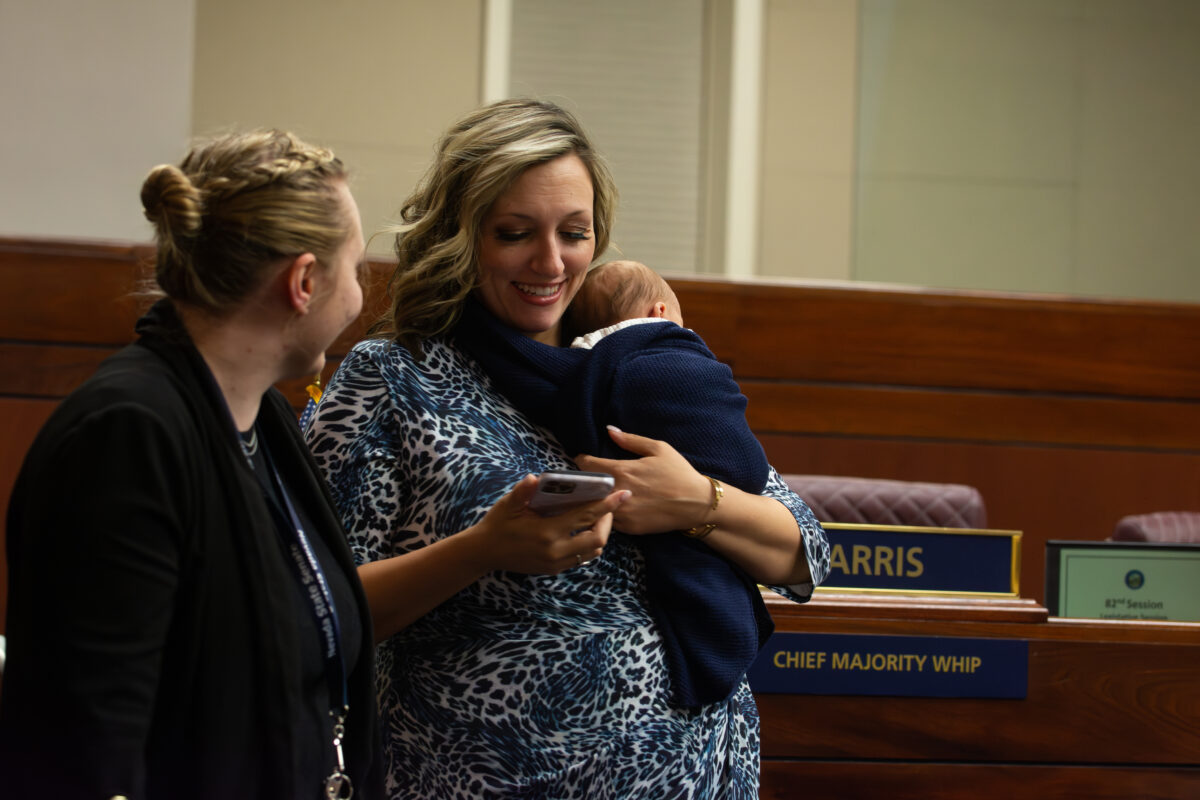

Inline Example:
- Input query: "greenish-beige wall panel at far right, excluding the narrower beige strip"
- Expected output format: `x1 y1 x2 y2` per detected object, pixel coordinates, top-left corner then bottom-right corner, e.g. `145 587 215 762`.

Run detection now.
853 0 1200 301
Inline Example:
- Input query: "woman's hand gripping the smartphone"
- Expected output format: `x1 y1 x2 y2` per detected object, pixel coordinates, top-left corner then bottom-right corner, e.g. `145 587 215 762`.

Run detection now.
462 475 630 575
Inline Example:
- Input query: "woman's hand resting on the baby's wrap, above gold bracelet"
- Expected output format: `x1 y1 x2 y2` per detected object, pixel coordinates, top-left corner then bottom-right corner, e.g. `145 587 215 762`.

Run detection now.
575 426 713 534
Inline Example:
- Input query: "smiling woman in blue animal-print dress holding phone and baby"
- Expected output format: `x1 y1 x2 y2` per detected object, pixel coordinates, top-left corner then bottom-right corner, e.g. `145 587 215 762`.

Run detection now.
308 100 828 800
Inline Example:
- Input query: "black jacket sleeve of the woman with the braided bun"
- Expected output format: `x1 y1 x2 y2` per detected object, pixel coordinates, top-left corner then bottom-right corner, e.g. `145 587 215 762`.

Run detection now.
0 403 190 798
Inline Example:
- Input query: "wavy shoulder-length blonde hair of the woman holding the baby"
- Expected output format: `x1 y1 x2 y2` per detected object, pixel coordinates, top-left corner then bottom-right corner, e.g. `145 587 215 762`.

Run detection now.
370 100 617 359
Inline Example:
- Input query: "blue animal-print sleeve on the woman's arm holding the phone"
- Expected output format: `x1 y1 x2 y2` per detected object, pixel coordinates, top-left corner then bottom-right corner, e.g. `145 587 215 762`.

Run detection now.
305 345 413 565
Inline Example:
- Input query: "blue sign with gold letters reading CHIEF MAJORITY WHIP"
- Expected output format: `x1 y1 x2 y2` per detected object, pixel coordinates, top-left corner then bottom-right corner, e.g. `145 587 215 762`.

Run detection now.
746 633 1030 698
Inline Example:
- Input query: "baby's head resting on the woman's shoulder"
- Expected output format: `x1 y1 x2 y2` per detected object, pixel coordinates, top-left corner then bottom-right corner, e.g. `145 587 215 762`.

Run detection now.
563 261 683 341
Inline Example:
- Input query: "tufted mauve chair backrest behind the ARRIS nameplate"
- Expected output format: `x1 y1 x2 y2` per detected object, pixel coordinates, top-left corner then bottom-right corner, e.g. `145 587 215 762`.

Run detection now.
782 475 988 528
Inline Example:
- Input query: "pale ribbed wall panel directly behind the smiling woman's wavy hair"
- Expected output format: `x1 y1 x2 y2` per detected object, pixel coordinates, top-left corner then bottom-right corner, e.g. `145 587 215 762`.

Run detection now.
509 0 704 272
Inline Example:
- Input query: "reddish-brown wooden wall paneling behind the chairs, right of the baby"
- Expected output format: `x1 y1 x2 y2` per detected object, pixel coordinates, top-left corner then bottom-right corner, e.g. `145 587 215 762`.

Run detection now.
671 277 1200 600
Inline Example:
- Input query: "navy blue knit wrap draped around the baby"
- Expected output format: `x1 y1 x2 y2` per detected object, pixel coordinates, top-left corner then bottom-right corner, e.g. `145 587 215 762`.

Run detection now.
454 299 774 706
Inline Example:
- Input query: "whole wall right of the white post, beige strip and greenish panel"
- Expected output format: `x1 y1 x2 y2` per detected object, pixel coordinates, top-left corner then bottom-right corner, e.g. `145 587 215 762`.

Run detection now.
758 0 1200 302
